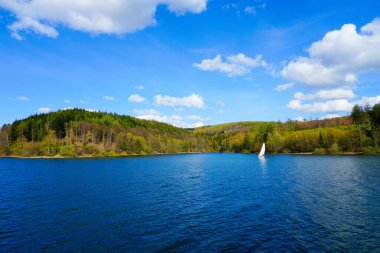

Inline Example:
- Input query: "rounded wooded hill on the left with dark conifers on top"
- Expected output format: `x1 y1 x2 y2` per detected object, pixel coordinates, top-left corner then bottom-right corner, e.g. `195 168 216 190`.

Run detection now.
0 109 209 157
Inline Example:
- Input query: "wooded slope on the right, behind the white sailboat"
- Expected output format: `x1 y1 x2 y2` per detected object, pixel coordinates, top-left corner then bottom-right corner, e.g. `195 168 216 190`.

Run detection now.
195 104 380 154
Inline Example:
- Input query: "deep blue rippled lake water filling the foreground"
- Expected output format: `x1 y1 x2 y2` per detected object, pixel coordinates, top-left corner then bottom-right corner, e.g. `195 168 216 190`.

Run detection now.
0 154 380 252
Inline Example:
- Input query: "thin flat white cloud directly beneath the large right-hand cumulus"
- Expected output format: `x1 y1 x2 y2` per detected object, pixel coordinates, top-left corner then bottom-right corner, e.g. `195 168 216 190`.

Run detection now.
294 88 355 100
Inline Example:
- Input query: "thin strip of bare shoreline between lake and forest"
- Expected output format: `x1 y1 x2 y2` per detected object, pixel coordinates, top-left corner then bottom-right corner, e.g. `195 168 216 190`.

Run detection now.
0 152 380 159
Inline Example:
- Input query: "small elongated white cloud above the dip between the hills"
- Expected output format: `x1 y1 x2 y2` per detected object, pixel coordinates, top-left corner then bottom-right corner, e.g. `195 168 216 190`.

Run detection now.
154 94 205 108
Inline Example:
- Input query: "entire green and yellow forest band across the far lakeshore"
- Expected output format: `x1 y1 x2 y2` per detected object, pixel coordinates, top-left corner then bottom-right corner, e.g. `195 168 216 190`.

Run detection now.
0 103 380 157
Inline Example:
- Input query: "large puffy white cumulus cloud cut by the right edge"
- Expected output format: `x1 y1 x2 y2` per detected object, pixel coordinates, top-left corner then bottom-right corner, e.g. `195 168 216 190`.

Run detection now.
281 19 380 87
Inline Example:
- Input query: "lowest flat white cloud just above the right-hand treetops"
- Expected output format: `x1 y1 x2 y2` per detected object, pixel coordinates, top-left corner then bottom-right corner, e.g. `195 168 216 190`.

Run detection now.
287 99 353 113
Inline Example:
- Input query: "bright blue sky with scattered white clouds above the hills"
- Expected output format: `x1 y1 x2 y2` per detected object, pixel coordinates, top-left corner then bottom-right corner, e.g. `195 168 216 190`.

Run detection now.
0 0 380 127
